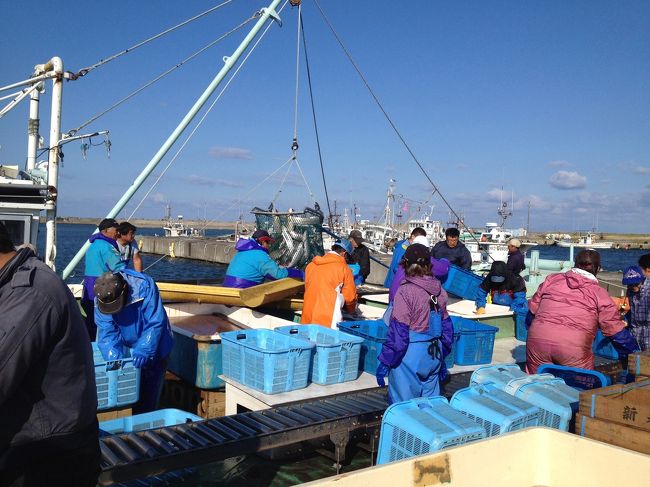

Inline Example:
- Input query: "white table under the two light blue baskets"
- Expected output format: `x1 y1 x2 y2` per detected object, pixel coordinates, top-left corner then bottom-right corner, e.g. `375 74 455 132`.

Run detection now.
219 372 377 416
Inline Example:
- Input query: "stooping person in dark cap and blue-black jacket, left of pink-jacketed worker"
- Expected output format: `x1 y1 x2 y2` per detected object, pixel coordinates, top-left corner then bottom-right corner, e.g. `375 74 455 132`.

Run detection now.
475 261 528 315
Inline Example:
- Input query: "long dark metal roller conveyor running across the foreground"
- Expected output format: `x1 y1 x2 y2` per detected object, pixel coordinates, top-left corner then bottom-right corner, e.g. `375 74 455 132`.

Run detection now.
99 389 388 485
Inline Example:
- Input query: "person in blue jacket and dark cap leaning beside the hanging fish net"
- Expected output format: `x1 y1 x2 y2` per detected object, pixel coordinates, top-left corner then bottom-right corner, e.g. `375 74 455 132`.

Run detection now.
223 230 305 288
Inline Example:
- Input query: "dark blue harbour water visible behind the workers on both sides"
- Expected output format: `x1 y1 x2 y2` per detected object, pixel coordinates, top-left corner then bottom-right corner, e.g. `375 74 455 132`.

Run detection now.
39 223 648 283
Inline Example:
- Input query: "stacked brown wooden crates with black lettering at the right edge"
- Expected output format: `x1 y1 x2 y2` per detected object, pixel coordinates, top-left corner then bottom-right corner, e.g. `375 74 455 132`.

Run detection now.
575 376 650 454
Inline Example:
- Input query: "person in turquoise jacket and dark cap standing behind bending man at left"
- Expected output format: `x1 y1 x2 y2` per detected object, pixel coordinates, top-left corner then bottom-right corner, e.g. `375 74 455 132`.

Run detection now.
81 218 126 342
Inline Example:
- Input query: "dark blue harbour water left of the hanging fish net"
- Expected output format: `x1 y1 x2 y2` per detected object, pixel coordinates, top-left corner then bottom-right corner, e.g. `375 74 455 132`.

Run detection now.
39 223 231 283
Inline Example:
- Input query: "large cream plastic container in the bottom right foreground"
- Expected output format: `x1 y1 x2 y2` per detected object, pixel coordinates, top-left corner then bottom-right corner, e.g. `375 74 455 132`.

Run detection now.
304 428 650 487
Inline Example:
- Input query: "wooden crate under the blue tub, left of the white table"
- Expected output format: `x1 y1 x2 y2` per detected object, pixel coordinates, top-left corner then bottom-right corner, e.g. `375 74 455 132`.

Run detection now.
160 372 226 419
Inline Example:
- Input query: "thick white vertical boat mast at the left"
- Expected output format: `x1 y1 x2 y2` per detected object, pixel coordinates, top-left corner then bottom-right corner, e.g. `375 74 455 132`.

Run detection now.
43 57 63 270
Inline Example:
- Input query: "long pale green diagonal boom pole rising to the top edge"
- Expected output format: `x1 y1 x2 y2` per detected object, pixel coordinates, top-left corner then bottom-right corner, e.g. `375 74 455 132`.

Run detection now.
63 0 281 279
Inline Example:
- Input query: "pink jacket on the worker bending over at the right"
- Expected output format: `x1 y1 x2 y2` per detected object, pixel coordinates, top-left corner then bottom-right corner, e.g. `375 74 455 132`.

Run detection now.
528 268 638 356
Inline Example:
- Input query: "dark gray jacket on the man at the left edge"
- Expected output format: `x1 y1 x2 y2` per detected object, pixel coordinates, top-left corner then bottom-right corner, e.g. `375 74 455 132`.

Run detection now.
0 249 97 453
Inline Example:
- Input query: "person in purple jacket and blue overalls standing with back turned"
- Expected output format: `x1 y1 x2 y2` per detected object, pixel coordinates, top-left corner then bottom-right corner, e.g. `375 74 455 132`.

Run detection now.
376 243 454 404
